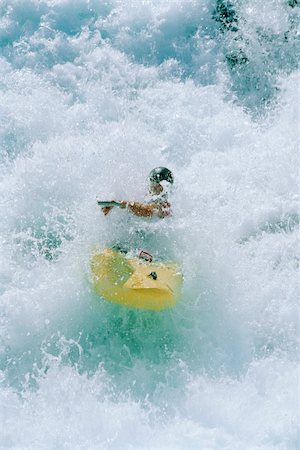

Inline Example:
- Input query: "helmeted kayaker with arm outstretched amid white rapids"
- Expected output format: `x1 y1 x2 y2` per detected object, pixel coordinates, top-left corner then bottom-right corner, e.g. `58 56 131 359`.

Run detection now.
102 167 174 219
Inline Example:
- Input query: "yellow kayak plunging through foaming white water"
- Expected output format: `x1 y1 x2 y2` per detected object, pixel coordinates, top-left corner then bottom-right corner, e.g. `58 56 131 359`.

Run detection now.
91 249 183 311
